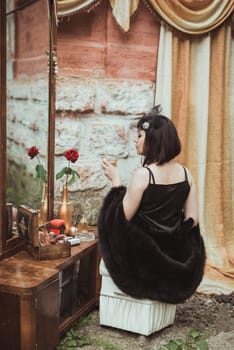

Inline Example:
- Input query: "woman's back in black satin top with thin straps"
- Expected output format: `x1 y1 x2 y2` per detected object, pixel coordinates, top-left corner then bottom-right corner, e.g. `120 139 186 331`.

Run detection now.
135 162 190 232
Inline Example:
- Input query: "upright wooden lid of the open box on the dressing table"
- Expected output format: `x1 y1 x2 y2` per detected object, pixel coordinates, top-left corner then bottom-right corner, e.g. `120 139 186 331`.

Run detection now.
16 205 40 247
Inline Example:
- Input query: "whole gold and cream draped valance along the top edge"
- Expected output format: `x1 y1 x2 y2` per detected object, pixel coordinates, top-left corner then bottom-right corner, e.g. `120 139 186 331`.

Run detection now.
57 0 234 35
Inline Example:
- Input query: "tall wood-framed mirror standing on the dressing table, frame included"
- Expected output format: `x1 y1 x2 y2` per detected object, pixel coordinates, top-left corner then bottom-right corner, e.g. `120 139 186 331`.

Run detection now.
1 0 54 258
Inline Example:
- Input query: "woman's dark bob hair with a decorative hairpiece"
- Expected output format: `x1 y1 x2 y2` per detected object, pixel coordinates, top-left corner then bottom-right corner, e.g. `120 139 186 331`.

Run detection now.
137 105 181 165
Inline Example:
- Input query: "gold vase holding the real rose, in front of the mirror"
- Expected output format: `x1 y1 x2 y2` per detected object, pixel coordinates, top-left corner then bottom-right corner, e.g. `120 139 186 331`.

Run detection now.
58 186 72 234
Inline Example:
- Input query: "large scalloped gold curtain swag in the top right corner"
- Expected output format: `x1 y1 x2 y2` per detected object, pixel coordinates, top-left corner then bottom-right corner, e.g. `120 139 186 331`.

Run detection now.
147 0 234 35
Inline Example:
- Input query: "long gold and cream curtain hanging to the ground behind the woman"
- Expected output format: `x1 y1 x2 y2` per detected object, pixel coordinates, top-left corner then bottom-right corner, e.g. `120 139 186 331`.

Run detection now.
155 24 234 293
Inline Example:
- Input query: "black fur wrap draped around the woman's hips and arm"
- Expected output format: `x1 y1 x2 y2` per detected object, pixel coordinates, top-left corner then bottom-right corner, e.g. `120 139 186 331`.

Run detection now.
98 186 205 304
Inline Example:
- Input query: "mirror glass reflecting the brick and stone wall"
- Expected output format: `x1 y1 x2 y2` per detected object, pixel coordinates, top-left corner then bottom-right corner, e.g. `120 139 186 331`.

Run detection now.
6 0 49 238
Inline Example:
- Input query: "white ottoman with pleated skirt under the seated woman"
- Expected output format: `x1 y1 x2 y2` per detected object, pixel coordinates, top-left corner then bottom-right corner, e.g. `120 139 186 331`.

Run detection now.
99 259 176 335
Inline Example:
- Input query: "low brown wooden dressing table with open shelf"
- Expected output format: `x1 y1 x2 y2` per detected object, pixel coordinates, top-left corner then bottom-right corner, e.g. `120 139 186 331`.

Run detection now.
0 239 100 350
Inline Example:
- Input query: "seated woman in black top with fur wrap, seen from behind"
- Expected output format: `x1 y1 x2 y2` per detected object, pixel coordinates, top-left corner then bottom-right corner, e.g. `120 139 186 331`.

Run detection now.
98 106 205 303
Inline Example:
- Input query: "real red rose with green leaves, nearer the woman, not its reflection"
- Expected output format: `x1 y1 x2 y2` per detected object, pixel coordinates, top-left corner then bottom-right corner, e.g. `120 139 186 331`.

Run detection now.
56 148 80 186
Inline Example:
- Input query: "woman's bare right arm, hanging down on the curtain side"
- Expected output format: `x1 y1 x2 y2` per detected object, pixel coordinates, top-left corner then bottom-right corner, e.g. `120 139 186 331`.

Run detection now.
184 169 199 225
